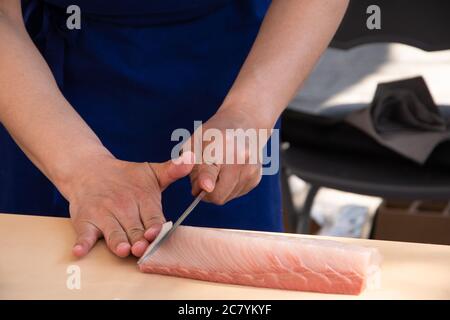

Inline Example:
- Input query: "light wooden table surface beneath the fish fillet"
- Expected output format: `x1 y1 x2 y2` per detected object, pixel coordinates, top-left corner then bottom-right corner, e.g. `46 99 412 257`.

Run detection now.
0 214 450 299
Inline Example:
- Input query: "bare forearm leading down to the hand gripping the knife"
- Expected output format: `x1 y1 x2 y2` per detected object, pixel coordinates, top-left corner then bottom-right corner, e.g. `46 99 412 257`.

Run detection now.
221 0 348 128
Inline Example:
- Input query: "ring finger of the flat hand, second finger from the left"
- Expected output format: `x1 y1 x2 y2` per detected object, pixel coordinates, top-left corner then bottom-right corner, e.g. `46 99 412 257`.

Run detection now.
101 214 131 258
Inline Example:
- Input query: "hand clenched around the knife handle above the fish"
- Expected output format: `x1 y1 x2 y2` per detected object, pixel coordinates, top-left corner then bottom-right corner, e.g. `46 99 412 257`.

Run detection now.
190 109 270 205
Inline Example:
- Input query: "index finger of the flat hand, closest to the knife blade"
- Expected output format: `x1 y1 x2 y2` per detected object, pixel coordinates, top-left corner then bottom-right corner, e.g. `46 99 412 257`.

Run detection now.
139 198 166 242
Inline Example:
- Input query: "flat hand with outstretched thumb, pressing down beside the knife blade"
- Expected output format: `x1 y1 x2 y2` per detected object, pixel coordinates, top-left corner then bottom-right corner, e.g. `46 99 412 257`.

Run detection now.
68 153 193 257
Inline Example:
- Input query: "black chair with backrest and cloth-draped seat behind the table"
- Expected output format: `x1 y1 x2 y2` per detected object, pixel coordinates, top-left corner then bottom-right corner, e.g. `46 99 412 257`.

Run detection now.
281 0 450 233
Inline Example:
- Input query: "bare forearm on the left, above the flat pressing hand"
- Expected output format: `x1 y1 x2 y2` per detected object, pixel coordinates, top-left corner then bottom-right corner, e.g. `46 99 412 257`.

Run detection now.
0 3 111 198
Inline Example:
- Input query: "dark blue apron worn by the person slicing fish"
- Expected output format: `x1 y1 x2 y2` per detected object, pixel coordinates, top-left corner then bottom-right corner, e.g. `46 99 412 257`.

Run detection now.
0 0 282 231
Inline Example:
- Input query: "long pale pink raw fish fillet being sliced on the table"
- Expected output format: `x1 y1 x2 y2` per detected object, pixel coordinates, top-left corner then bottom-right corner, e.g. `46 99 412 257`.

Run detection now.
139 222 381 294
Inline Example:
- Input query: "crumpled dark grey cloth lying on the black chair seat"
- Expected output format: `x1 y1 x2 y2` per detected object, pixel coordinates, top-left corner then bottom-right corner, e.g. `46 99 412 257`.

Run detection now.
345 77 450 164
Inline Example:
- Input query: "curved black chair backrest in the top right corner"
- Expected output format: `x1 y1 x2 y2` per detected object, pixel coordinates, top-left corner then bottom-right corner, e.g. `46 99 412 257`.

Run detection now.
331 0 450 51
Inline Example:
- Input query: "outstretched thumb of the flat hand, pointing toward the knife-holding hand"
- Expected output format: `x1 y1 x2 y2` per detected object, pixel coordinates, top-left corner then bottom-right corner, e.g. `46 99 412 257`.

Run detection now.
149 151 195 190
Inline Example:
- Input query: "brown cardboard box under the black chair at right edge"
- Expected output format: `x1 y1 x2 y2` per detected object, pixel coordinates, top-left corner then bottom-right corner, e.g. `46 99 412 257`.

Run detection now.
372 200 450 245
